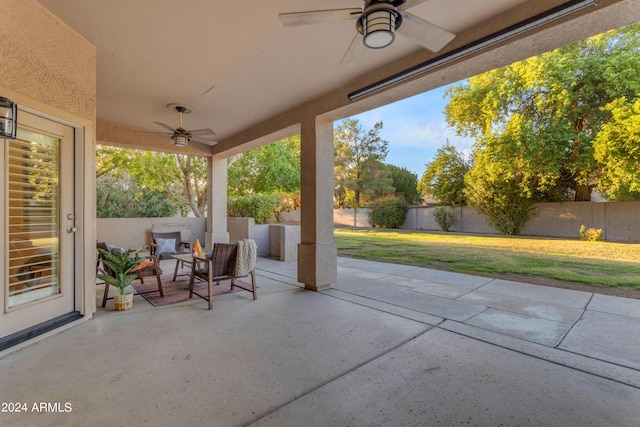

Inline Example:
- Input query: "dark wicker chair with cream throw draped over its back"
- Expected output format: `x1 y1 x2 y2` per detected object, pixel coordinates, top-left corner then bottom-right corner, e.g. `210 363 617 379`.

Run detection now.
189 239 258 310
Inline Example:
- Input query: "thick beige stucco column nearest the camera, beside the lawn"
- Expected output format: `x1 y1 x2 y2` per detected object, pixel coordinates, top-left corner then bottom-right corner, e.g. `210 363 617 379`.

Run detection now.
298 118 338 291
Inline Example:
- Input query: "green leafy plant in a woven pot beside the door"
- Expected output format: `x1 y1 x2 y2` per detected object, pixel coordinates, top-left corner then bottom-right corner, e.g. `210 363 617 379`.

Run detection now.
98 249 144 311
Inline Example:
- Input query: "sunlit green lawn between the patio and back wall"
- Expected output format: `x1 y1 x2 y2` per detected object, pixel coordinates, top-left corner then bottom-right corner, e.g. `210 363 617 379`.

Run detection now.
335 228 640 288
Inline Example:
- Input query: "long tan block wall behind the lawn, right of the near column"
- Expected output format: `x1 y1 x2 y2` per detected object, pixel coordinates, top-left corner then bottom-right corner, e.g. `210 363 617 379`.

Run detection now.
333 202 640 242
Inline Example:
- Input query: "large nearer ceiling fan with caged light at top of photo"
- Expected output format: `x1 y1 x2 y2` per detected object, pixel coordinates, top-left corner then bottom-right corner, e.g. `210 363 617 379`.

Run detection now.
278 0 455 64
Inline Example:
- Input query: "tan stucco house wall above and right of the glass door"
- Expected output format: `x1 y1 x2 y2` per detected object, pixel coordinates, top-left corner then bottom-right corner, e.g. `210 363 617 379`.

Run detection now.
0 0 96 322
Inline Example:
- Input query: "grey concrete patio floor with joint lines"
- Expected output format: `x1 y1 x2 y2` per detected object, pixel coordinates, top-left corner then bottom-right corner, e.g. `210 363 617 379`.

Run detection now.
0 258 640 427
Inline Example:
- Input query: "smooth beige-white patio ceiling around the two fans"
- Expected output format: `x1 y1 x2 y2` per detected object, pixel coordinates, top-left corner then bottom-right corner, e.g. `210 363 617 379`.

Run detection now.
33 0 624 150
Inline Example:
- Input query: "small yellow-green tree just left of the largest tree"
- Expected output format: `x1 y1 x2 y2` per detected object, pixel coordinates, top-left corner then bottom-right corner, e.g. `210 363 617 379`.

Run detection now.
418 142 469 206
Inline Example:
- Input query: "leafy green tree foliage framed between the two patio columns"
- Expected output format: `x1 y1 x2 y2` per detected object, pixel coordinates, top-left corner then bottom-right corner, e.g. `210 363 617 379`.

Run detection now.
227 135 300 197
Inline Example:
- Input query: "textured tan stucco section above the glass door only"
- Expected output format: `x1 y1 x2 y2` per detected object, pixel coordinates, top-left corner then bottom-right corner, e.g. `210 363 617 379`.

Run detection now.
0 0 96 124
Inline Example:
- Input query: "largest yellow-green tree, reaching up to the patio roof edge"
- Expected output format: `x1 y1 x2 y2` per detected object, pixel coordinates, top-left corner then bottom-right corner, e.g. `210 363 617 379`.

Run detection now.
445 24 640 200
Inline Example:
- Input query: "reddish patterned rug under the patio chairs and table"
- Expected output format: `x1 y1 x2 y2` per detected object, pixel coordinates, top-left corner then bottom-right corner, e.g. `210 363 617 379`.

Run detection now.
132 274 246 307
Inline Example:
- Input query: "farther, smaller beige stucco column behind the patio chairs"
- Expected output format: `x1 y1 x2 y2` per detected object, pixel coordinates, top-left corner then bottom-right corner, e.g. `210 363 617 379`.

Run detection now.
205 157 229 250
